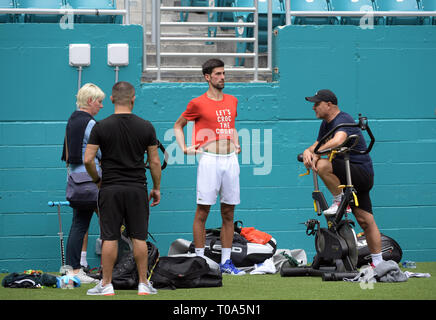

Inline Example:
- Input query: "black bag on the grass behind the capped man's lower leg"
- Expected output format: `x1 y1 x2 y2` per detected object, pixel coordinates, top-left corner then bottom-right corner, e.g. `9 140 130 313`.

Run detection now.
357 234 403 268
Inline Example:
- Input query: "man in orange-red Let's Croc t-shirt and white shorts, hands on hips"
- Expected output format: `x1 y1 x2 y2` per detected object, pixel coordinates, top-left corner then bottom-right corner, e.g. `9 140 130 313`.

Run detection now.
174 59 245 275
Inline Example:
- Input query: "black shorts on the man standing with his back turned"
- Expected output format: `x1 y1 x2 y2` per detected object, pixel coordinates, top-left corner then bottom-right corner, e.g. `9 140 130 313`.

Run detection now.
98 185 149 240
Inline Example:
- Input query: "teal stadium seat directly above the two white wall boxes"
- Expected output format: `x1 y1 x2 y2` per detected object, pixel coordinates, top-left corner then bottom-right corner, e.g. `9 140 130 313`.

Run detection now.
66 0 123 23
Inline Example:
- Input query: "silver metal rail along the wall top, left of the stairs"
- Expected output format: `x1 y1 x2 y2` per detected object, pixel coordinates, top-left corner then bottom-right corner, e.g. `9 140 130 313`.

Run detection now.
0 0 130 24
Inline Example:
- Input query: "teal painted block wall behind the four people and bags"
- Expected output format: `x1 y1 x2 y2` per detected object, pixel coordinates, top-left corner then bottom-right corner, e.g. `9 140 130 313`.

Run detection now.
0 24 436 272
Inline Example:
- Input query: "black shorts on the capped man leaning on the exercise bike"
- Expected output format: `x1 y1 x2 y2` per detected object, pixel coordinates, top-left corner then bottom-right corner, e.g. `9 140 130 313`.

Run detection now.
332 159 374 214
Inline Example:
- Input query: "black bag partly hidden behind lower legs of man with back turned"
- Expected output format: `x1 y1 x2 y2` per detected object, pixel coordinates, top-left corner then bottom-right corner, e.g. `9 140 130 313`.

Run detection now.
112 241 159 290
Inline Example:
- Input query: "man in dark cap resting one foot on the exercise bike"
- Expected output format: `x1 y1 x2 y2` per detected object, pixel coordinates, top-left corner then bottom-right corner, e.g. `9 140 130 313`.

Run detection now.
303 89 383 266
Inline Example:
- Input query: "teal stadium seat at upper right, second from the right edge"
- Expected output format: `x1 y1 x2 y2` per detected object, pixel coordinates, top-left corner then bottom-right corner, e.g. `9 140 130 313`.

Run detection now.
376 0 424 25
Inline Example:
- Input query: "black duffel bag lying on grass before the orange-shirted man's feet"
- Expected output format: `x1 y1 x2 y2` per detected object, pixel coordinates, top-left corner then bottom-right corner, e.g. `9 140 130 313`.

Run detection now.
150 256 222 290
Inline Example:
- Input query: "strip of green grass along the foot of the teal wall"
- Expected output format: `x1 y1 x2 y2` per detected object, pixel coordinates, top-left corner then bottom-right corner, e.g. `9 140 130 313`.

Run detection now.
0 262 436 301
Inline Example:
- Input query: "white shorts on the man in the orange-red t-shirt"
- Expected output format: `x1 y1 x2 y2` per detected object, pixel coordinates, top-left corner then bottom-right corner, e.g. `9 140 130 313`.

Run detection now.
197 152 241 205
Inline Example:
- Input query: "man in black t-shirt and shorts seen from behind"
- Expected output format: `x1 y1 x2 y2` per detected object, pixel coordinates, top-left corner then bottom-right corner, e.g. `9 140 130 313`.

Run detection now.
85 82 161 295
